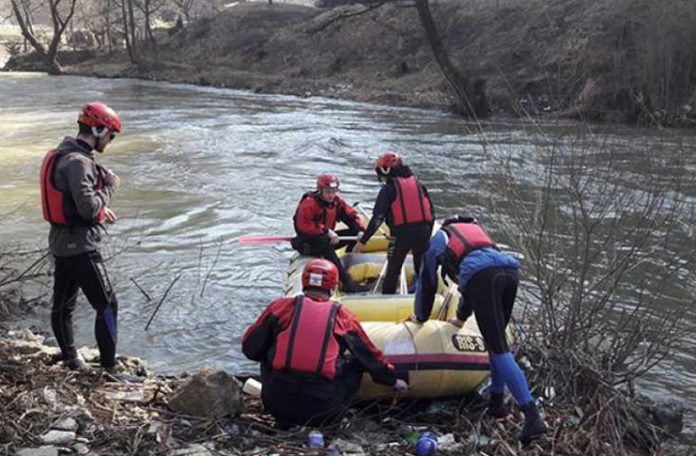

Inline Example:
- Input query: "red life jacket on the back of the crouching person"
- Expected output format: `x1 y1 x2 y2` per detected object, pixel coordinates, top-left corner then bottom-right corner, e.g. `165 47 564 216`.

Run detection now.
272 295 340 379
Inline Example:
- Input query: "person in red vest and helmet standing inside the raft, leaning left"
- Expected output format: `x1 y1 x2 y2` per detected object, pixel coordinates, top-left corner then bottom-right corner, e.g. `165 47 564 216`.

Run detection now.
353 152 434 294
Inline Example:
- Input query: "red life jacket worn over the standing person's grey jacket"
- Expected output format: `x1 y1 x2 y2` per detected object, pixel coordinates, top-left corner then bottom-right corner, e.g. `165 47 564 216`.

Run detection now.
40 149 105 226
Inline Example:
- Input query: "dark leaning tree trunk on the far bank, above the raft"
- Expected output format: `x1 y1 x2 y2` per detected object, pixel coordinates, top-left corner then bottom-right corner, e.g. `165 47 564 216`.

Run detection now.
416 0 490 117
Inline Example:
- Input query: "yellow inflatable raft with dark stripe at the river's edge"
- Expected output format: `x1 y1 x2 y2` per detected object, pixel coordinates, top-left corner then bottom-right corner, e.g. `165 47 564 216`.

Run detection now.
285 241 489 399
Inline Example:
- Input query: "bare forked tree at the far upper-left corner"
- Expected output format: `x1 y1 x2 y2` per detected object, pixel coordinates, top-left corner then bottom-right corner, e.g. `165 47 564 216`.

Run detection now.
11 0 77 74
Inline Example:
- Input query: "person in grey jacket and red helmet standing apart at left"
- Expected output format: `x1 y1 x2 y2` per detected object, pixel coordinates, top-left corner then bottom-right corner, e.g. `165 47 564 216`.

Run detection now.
40 102 121 370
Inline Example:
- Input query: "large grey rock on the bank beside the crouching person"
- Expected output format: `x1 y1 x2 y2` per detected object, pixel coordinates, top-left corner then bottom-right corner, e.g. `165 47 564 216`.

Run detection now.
169 369 242 419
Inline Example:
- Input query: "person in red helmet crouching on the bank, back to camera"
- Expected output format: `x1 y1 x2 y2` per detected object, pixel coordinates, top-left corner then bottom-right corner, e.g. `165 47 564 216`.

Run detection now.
242 259 408 428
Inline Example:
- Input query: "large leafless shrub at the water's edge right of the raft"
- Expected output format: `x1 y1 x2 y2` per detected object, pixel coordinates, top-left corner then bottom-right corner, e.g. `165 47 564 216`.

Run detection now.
482 124 696 454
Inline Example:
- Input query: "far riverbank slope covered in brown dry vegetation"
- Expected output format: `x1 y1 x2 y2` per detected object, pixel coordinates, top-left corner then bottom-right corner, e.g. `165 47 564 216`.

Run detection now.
8 0 696 125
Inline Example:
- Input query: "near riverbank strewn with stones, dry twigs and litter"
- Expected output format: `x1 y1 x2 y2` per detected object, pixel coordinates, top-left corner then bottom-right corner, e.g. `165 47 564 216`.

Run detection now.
0 330 686 456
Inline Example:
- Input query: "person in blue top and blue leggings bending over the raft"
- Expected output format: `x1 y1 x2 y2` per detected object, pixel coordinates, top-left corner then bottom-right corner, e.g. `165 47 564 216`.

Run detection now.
410 215 547 444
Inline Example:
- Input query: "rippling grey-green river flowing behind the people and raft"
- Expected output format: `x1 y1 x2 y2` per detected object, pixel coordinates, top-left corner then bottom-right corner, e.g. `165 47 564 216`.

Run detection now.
0 73 696 428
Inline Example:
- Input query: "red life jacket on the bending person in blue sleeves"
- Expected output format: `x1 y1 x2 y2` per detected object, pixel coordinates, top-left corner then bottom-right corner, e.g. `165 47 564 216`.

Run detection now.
442 222 498 278
